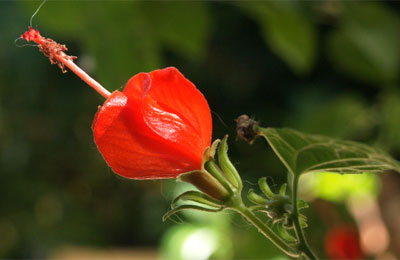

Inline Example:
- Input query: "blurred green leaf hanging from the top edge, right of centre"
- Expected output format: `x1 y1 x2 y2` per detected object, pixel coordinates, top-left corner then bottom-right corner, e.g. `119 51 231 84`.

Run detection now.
239 1 317 74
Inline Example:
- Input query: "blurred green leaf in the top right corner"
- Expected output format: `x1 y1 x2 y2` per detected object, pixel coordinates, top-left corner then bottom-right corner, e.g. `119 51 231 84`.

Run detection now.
328 2 400 85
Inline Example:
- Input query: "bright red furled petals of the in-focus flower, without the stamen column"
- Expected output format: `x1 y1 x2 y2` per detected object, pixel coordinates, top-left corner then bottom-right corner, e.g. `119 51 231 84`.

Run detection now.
92 67 212 179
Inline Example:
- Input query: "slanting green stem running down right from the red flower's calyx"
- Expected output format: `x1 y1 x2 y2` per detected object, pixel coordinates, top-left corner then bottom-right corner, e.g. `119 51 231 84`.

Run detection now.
230 198 301 258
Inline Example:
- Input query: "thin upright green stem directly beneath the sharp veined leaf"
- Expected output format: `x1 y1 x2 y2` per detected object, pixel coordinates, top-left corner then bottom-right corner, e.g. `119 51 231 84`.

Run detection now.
289 173 318 259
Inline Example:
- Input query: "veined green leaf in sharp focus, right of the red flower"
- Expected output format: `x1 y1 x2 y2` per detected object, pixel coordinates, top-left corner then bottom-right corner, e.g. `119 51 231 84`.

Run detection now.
260 128 400 175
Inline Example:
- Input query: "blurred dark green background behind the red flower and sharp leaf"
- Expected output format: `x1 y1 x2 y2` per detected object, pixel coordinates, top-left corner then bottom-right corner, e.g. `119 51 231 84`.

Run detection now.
0 1 400 260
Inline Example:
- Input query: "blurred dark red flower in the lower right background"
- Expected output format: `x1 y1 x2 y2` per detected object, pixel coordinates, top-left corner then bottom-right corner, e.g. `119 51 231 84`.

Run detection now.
325 226 362 259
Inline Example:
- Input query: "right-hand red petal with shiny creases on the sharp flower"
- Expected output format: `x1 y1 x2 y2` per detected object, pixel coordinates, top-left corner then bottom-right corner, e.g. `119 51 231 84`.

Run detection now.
124 67 212 165
